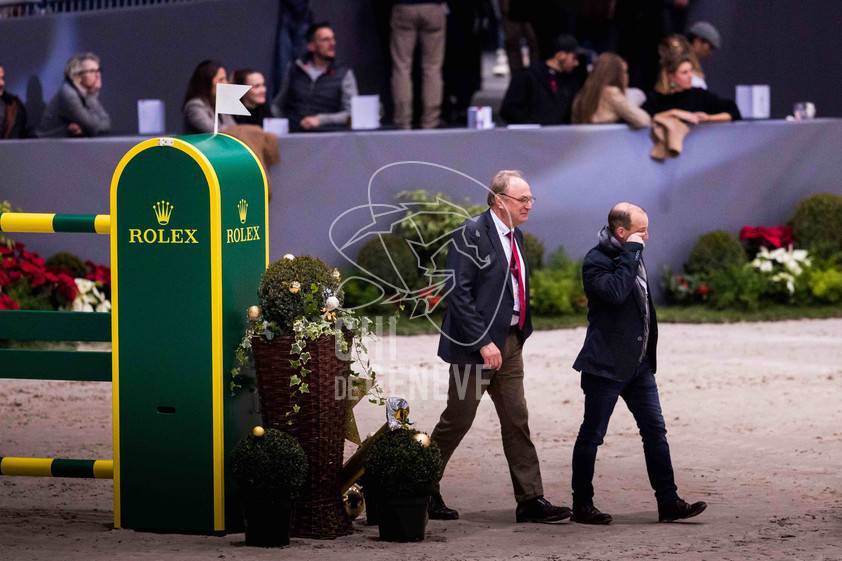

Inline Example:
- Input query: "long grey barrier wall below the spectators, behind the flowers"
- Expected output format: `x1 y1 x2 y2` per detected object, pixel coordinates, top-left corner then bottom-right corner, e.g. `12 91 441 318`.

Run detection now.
0 119 842 302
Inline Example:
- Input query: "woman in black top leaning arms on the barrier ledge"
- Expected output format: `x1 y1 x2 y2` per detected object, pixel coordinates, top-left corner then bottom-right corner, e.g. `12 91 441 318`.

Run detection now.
643 56 741 125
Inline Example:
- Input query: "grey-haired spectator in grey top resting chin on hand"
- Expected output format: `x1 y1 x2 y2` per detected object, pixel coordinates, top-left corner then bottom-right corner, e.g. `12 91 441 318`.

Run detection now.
35 53 111 137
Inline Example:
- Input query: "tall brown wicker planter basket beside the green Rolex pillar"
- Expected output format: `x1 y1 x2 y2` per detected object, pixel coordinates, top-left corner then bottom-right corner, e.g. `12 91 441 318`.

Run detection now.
252 337 351 539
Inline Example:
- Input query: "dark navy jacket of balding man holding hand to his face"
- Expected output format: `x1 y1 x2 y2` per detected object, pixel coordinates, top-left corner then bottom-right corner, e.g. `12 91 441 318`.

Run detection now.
573 237 658 381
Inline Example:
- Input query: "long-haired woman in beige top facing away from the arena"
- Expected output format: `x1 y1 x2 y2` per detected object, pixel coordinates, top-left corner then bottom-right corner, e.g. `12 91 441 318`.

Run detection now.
573 53 651 128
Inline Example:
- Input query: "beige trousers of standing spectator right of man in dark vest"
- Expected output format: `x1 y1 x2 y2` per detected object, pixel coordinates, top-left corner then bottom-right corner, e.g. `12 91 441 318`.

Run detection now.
390 0 447 129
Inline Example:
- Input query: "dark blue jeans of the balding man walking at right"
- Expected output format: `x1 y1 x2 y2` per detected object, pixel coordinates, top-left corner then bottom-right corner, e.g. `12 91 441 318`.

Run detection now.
573 361 678 506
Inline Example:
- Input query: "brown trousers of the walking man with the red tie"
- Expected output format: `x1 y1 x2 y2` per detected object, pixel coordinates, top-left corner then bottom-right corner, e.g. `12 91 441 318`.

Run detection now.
431 330 544 502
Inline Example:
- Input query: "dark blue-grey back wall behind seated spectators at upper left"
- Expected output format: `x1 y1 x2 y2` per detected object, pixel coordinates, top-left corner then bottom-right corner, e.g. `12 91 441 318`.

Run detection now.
0 0 279 134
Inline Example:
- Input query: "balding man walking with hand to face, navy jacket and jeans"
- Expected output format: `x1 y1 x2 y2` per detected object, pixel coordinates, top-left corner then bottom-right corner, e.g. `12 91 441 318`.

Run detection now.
573 203 707 524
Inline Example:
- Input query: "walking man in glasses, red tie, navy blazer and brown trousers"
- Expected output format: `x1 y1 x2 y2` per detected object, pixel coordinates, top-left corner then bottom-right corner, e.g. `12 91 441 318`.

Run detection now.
428 170 570 524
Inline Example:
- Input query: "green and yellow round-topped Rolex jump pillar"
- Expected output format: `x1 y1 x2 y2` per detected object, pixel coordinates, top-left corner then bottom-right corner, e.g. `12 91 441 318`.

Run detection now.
111 135 268 532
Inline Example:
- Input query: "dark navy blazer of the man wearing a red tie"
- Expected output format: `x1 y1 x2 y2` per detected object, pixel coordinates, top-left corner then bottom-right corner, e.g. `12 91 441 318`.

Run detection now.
439 210 532 364
